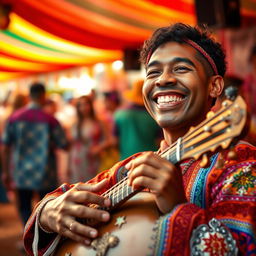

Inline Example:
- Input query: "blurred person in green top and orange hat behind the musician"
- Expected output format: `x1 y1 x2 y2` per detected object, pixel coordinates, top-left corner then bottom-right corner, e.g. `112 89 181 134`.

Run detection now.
114 79 161 160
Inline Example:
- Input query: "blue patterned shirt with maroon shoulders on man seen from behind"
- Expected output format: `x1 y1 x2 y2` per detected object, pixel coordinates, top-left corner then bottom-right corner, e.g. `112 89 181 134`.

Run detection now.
2 104 67 190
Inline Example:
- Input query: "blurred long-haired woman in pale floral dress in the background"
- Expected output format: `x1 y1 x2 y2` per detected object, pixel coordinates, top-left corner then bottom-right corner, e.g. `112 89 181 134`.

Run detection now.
68 95 106 183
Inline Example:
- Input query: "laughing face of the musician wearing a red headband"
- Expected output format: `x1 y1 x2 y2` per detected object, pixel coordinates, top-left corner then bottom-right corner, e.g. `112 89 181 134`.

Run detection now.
143 42 212 130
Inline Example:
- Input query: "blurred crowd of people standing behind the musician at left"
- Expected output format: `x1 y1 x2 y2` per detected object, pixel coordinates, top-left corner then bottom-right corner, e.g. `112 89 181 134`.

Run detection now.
0 80 162 238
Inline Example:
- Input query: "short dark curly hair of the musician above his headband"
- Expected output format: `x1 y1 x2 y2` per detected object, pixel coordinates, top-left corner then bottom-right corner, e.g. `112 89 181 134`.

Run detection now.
140 23 226 76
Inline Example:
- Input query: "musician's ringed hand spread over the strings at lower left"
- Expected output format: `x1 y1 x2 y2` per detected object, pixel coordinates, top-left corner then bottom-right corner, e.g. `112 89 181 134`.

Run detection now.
39 180 111 245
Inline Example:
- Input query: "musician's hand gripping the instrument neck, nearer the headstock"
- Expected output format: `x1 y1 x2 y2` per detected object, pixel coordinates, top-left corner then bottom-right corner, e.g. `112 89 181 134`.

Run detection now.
125 152 187 214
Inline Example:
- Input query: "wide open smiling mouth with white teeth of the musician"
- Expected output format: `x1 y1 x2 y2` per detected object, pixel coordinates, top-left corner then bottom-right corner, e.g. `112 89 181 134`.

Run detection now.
153 92 187 110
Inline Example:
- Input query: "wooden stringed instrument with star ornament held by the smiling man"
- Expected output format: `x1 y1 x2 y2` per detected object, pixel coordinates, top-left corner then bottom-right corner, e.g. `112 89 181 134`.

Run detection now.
55 96 247 256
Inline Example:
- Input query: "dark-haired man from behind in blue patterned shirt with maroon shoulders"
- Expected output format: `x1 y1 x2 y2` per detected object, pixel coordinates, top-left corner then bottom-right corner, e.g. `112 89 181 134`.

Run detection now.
1 83 67 225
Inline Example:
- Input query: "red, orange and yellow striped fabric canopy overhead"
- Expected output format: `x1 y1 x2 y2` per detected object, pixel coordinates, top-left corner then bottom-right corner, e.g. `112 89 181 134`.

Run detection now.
0 0 256 81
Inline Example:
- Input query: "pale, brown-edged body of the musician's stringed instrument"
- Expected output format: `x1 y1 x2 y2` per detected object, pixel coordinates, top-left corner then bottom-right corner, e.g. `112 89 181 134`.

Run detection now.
55 192 159 256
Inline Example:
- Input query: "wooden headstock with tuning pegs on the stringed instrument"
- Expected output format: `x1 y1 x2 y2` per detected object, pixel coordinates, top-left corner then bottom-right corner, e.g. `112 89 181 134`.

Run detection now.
162 96 247 165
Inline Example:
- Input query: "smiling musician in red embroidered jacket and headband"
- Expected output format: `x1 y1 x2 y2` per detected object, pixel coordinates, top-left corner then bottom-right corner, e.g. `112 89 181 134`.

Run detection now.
24 23 256 255
